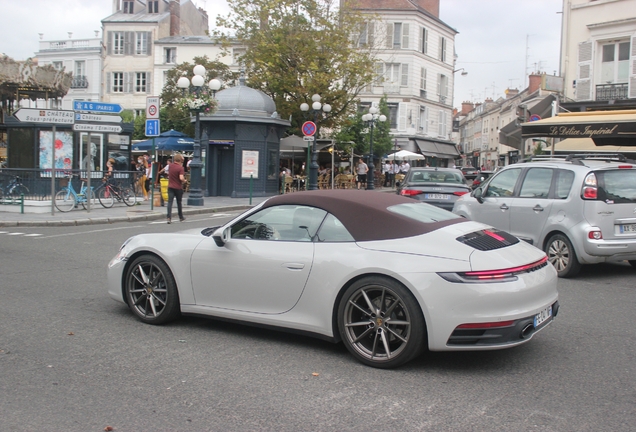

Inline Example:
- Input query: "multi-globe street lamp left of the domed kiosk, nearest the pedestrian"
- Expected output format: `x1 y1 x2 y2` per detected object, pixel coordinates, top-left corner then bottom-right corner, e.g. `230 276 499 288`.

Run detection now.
177 65 221 206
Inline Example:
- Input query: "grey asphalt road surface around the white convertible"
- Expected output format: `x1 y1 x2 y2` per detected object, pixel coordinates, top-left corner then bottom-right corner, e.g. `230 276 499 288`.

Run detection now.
0 215 636 432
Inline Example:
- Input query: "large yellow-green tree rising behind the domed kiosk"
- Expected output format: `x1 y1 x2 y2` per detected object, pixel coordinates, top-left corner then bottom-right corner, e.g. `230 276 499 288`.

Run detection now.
217 0 374 133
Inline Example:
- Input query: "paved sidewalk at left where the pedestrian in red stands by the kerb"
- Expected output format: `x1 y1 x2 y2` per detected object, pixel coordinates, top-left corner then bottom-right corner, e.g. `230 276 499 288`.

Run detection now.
0 194 269 227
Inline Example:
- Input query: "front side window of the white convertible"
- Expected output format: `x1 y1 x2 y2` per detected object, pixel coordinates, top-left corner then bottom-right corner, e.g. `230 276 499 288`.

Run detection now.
231 205 327 241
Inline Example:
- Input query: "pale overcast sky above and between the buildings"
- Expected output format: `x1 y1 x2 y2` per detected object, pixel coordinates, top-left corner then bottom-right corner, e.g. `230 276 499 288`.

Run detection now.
0 0 562 107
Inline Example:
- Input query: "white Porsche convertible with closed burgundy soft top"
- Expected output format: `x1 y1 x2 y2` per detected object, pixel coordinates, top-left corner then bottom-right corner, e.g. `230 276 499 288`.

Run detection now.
108 190 559 368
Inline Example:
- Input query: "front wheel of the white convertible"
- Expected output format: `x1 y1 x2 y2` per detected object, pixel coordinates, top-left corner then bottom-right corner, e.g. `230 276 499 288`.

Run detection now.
124 255 180 324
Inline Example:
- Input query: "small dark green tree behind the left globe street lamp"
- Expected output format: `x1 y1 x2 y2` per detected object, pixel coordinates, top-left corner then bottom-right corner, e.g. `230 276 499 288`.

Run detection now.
159 56 236 136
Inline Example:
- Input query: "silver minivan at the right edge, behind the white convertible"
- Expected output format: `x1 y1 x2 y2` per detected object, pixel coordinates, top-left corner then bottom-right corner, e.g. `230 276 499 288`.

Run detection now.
453 155 636 277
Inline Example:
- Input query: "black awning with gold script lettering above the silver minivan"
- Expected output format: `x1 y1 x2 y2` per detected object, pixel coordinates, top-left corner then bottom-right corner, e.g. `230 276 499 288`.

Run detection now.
521 110 636 146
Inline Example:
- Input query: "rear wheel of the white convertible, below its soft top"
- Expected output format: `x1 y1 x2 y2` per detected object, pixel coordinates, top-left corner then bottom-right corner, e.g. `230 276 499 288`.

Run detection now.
338 277 426 369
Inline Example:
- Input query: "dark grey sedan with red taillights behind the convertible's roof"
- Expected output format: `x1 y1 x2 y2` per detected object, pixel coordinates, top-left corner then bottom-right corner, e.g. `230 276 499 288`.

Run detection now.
396 168 470 211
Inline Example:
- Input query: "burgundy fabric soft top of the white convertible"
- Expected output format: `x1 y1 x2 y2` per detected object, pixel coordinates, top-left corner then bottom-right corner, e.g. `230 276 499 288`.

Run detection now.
263 190 465 241
